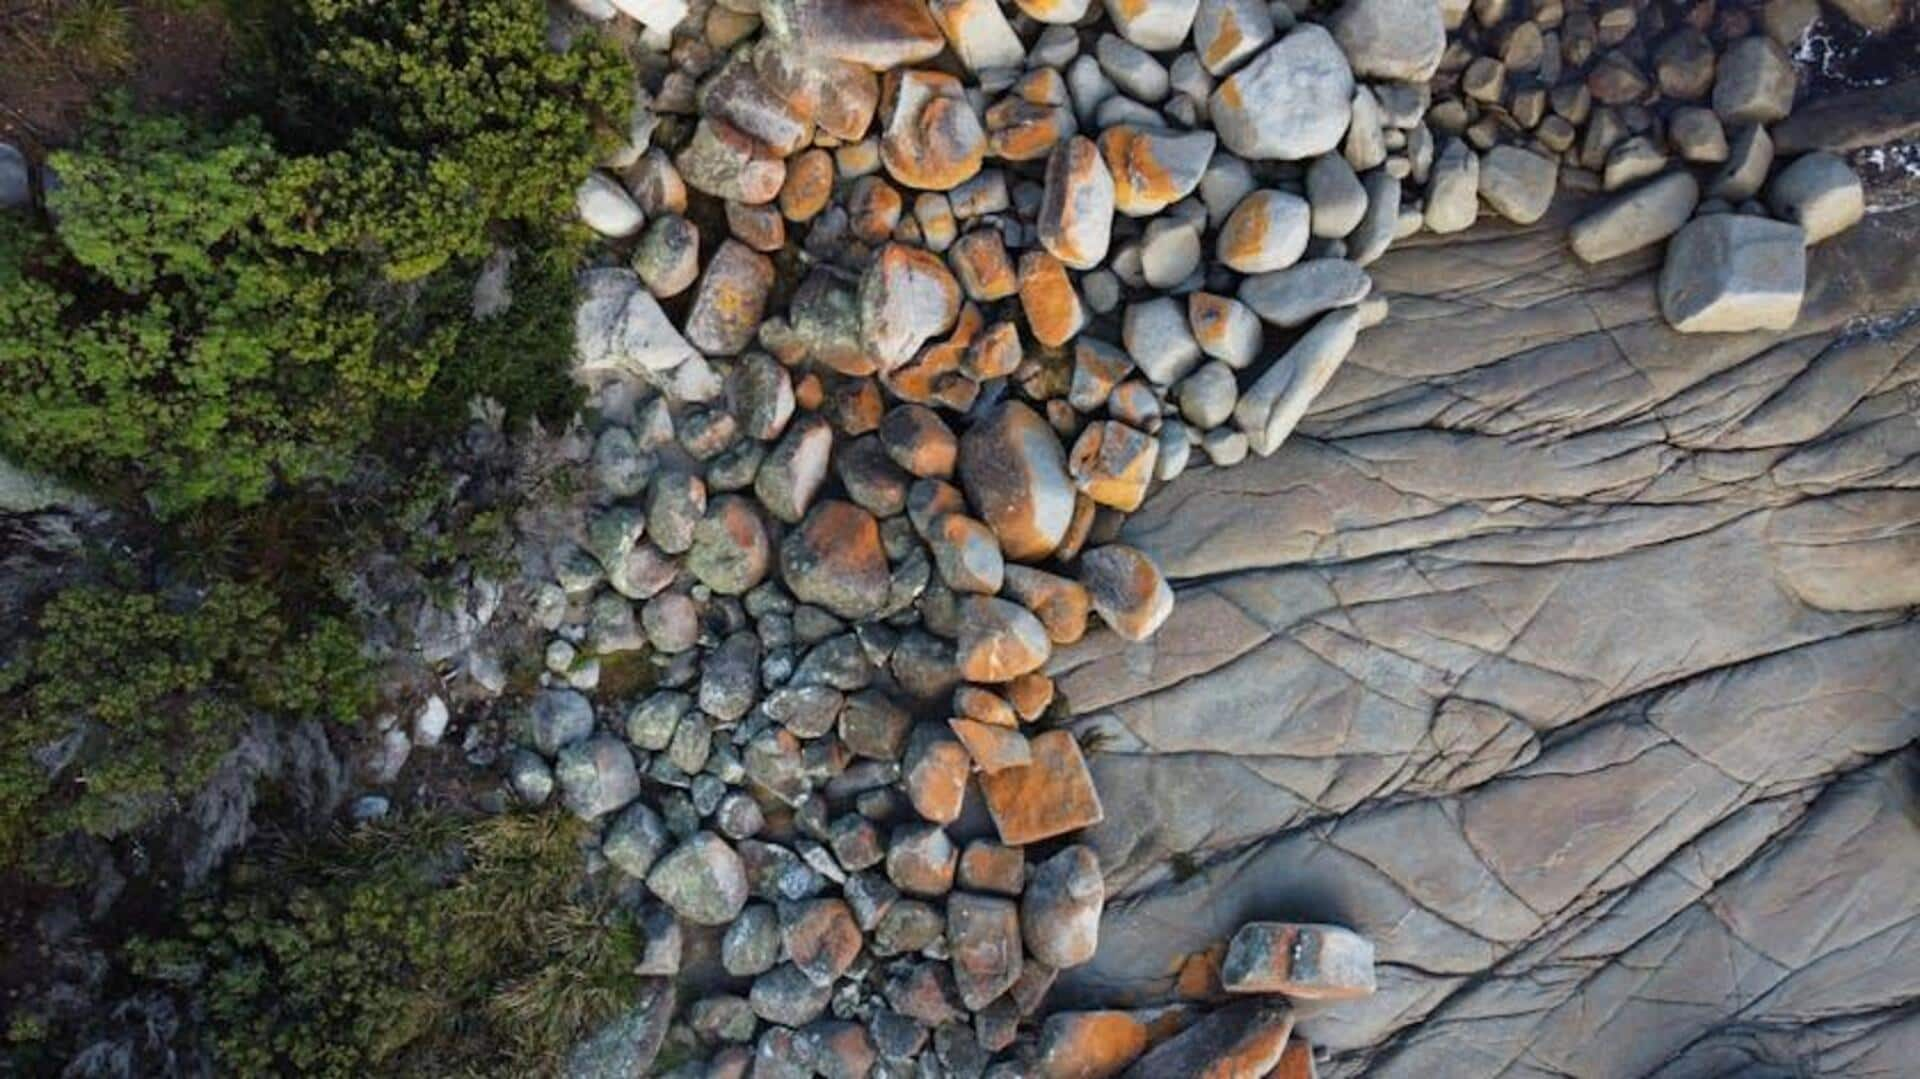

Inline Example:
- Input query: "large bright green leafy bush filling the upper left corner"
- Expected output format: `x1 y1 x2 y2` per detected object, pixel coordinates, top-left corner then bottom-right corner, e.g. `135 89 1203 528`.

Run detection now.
0 0 630 516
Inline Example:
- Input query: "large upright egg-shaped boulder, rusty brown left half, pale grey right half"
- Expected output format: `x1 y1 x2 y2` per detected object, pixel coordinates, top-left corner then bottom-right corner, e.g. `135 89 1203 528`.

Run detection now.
960 401 1073 564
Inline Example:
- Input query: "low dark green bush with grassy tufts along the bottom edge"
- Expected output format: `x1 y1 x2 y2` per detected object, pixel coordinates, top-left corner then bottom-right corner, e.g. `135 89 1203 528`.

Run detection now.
131 812 643 1077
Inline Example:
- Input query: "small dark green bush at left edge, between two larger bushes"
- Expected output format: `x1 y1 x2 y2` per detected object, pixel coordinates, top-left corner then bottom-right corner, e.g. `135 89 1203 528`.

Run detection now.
0 584 371 866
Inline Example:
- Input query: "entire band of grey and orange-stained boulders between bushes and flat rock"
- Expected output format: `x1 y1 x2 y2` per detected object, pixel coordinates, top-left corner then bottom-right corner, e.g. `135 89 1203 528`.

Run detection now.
511 0 1859 1075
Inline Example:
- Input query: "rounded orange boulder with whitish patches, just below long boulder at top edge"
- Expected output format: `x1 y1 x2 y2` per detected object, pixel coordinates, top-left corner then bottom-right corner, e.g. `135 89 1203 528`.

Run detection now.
879 71 987 192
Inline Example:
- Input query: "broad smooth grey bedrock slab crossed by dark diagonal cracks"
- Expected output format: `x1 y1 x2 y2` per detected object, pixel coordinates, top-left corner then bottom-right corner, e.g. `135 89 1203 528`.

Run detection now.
1050 200 1920 1079
